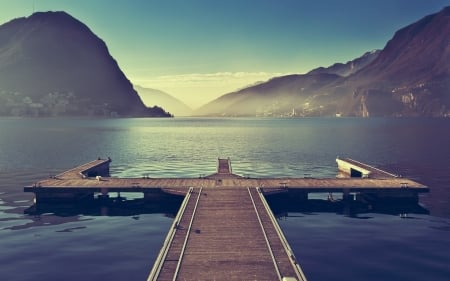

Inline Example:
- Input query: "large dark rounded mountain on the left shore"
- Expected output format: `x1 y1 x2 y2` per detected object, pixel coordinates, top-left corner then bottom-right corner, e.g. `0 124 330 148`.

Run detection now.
0 12 168 116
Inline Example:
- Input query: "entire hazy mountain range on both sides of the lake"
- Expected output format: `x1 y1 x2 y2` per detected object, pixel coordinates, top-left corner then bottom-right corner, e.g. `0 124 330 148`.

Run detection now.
0 7 450 117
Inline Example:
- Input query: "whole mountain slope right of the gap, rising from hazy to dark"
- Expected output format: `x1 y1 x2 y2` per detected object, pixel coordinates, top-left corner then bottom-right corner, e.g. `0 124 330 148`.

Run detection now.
193 7 450 117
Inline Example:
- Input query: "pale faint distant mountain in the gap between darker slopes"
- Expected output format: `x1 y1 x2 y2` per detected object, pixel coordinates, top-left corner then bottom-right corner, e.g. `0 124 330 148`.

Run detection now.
134 85 192 116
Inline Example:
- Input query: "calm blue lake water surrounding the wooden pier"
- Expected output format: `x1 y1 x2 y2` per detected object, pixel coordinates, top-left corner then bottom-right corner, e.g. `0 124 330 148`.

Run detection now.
0 118 450 281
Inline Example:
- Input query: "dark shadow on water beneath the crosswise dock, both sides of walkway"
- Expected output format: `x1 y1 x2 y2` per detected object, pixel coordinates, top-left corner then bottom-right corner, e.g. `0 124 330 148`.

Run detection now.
24 190 429 224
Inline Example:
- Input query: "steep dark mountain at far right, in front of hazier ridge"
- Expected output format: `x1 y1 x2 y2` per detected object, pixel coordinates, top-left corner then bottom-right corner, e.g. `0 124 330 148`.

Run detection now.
343 7 450 116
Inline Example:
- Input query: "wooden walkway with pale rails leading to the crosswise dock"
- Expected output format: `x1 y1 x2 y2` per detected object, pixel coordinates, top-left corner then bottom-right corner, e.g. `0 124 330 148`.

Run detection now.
148 187 306 280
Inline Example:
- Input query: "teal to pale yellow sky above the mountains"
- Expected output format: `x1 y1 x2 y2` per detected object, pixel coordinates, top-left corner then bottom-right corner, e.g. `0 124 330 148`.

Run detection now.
0 0 450 107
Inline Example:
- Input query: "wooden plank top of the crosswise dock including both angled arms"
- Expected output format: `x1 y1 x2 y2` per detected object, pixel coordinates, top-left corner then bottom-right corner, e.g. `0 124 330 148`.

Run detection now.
24 159 428 193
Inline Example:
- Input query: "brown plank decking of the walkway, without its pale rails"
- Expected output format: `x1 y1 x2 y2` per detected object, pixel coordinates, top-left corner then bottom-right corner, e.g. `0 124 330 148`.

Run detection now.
155 187 306 280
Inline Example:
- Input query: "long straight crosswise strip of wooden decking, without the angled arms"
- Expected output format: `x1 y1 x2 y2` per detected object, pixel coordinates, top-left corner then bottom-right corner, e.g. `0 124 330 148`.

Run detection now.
24 177 428 192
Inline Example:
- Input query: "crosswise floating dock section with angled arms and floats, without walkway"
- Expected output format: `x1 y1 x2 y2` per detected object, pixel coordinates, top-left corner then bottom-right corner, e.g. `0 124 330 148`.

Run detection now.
24 158 429 201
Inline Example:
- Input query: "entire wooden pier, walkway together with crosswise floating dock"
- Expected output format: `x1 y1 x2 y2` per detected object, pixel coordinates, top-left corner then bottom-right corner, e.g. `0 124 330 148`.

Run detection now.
24 158 428 281
